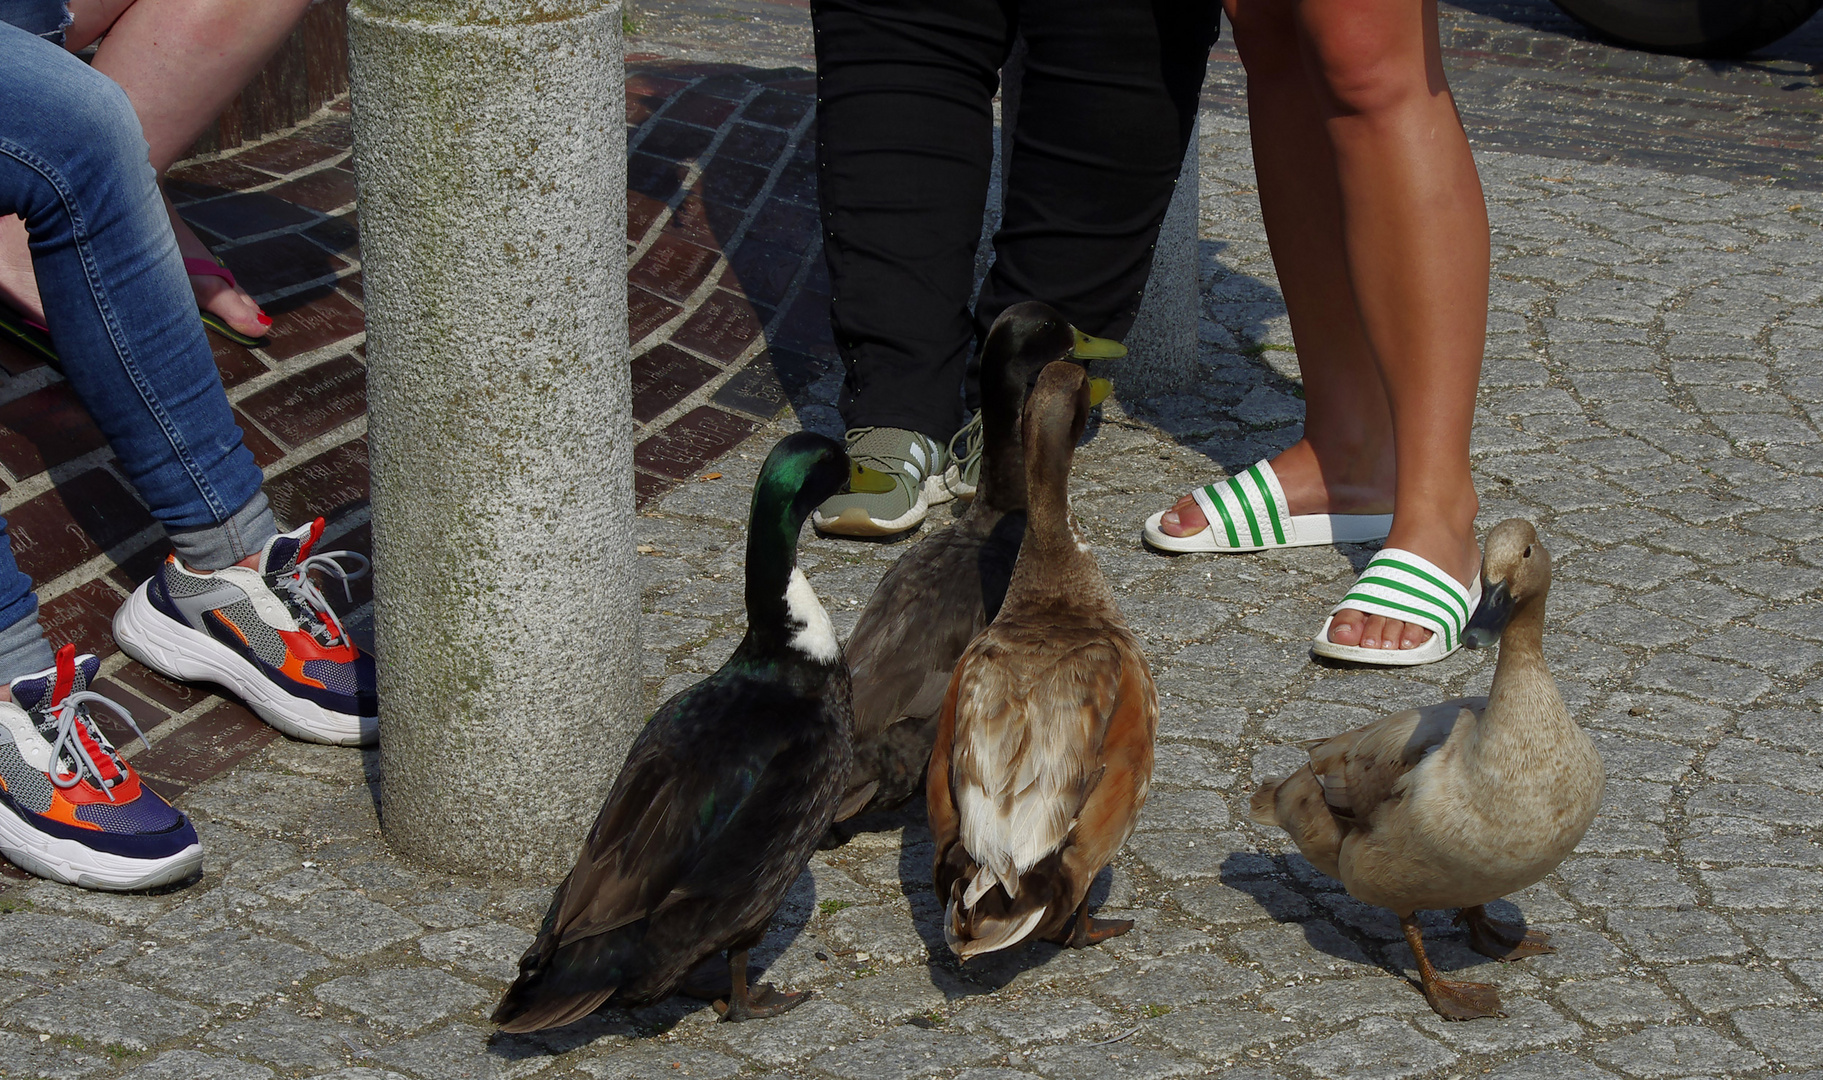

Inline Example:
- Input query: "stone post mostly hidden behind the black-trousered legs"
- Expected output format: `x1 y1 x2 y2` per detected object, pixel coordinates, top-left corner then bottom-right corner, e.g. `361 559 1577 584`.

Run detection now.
979 38 1203 401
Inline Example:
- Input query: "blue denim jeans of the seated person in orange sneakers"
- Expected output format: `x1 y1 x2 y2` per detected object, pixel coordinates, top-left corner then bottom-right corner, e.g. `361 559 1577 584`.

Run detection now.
0 24 275 679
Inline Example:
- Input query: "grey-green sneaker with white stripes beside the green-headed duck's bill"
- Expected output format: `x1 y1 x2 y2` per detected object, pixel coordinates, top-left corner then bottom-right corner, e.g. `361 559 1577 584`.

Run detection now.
811 427 955 536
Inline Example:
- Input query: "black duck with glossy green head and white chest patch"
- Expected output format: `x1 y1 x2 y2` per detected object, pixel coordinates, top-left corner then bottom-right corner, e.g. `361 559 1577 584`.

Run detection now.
494 432 853 1031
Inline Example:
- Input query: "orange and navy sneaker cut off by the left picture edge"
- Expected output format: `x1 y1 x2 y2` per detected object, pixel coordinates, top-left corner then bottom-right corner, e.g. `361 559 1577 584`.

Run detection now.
0 646 202 890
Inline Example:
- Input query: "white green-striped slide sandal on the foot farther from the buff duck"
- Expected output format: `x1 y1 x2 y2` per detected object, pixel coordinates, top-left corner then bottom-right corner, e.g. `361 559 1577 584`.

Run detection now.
1145 460 1393 553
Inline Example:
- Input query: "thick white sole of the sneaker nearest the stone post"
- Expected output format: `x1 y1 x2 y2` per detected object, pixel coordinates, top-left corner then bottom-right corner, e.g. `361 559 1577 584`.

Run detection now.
115 582 379 746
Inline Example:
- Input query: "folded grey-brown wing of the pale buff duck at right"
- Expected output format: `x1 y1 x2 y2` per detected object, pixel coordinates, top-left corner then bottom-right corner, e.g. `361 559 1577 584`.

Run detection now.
1303 699 1486 825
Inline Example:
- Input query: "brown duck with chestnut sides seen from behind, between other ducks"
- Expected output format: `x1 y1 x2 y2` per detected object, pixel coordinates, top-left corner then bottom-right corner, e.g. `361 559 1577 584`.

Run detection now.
926 363 1158 961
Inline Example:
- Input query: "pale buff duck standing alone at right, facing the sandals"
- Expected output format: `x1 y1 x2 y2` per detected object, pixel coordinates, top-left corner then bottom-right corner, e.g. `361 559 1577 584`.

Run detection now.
1252 518 1602 1020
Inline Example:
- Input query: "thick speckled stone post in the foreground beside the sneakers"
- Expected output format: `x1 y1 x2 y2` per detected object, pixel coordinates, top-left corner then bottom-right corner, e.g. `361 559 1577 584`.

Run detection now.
348 0 644 878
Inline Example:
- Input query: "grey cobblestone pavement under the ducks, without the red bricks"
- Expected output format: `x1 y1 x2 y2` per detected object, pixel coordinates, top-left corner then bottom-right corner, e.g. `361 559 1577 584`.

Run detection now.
0 5 1823 1080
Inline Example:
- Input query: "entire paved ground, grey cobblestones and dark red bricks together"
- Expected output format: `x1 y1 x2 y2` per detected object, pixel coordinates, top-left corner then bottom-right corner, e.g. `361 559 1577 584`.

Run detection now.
0 2 1823 1080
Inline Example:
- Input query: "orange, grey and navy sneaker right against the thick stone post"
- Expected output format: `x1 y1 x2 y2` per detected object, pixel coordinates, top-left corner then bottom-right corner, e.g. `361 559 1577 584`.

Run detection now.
115 518 379 746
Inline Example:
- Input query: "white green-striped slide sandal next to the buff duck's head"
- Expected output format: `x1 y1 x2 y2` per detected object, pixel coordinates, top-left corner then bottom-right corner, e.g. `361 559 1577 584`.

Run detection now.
1311 547 1480 668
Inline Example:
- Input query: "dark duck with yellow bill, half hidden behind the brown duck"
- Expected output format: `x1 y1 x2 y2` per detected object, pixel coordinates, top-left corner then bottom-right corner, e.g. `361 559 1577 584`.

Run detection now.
835 303 1127 821
